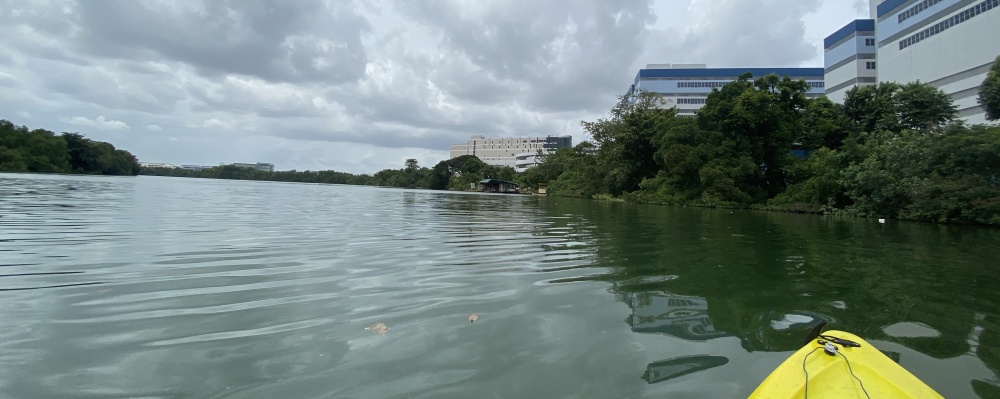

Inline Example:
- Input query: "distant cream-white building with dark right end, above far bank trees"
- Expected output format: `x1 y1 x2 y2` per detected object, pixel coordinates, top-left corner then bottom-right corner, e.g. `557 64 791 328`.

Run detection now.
450 135 573 171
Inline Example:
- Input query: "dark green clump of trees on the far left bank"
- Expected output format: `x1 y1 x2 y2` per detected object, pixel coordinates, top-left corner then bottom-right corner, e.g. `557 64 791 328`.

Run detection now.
0 119 139 175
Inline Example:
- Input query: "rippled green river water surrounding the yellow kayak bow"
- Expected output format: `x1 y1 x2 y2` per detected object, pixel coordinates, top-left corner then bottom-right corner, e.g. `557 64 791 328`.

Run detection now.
0 174 1000 399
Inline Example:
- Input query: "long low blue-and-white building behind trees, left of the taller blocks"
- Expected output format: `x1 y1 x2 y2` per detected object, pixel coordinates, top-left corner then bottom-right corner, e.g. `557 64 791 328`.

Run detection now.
628 64 825 115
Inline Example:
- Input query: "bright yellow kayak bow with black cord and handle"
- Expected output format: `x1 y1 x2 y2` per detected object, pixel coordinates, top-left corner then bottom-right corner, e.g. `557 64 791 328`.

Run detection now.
750 331 941 399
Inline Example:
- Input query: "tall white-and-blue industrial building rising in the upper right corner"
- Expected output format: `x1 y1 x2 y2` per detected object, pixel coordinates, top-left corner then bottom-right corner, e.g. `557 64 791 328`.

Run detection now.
824 0 1000 123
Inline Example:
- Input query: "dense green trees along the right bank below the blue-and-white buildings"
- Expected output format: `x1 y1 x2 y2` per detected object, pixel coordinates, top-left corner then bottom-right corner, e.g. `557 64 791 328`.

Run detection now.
520 75 1000 225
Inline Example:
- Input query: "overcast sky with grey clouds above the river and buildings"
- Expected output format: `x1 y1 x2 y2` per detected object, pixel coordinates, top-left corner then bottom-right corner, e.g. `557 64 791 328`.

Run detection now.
0 0 868 174
